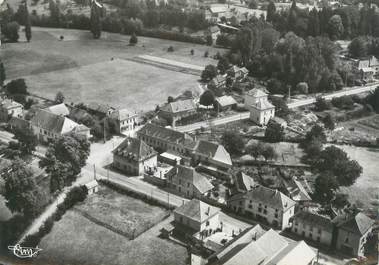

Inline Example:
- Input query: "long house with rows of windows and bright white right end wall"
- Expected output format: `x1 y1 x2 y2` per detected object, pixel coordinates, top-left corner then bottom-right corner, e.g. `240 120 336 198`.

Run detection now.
227 185 296 230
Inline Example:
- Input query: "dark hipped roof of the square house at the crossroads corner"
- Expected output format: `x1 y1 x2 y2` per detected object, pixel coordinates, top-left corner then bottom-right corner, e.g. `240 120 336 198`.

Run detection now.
113 138 157 162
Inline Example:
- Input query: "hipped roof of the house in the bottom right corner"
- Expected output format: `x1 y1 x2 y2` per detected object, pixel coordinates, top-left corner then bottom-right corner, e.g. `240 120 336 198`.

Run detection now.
333 212 375 235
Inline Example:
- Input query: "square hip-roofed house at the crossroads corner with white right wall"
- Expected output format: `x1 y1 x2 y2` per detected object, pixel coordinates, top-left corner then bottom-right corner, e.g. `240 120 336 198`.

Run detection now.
113 137 157 175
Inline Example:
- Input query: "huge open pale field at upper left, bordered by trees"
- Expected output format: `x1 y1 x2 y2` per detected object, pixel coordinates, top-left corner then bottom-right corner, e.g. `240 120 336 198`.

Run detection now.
0 27 226 111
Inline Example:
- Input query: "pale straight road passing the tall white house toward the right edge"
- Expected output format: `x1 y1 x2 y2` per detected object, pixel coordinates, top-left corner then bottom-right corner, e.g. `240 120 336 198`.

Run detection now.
175 83 379 132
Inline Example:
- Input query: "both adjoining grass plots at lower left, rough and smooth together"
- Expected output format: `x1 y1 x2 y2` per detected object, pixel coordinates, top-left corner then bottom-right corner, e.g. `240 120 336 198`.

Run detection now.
33 186 188 265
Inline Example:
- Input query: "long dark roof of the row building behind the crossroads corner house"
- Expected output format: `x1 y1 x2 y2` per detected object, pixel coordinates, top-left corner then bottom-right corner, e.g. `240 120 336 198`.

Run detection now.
138 123 193 143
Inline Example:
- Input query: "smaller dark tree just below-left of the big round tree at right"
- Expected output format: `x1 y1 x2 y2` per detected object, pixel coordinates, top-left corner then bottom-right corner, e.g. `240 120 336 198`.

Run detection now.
313 172 339 204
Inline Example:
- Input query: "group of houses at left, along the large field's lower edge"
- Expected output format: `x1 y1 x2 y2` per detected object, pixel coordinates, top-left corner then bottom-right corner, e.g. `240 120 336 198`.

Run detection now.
0 98 137 143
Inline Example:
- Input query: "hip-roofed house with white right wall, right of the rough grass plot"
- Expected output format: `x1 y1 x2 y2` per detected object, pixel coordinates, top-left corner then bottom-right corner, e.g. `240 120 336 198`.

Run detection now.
174 199 220 239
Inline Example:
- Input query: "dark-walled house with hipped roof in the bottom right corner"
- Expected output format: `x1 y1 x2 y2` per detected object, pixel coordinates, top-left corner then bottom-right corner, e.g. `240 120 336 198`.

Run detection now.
333 210 375 256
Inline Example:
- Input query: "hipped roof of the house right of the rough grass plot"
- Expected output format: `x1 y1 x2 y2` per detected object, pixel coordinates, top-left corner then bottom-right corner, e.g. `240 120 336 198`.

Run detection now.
174 199 220 223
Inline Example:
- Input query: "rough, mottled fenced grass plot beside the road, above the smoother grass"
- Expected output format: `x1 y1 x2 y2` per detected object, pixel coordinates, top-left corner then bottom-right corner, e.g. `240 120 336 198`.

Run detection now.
75 187 166 239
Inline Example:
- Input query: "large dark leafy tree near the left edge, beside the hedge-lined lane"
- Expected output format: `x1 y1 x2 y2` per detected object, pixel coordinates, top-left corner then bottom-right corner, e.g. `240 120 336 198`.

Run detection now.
4 159 42 217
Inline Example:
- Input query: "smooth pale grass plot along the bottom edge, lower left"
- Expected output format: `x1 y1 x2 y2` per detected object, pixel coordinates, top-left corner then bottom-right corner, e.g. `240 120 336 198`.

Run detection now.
33 211 187 265
